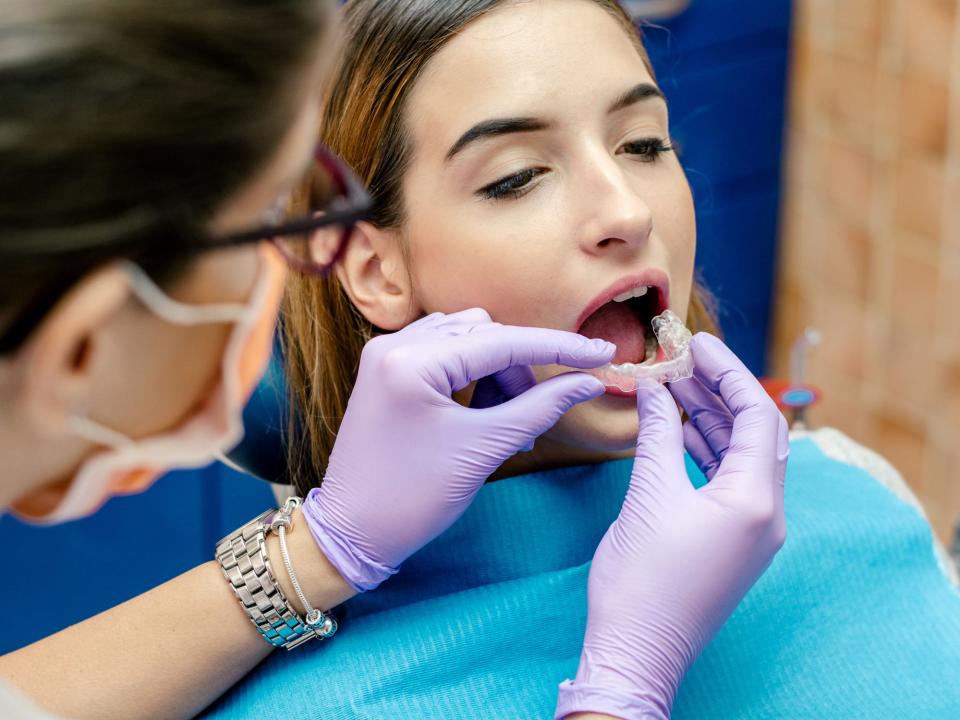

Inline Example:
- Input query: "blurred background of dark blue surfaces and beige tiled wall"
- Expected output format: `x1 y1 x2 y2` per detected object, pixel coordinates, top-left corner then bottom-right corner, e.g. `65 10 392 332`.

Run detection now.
0 0 960 653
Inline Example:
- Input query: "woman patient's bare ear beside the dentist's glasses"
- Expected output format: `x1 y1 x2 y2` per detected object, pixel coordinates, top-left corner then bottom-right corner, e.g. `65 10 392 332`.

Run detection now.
336 222 421 330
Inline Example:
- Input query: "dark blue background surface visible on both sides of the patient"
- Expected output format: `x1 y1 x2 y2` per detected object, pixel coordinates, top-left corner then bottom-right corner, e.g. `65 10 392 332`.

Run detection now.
0 0 790 653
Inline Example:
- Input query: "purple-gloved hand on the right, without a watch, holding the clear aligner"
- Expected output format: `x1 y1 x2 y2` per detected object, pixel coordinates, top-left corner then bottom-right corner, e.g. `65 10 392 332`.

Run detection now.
556 333 789 720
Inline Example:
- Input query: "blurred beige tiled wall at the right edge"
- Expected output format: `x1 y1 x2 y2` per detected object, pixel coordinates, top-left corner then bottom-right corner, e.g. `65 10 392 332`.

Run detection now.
771 0 960 539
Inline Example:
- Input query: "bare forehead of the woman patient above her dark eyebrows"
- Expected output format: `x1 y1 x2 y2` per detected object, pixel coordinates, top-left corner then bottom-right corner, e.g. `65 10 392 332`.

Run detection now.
407 0 653 160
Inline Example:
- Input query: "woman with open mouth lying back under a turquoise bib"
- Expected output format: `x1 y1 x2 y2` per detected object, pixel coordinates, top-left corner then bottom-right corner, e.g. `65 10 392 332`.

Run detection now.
204 0 960 718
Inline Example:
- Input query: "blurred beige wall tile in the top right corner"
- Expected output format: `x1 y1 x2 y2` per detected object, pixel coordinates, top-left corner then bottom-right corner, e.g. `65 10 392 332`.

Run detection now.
900 0 956 82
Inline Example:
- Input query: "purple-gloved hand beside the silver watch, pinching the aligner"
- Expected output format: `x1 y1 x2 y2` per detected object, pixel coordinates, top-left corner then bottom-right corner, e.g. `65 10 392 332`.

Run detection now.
303 309 615 592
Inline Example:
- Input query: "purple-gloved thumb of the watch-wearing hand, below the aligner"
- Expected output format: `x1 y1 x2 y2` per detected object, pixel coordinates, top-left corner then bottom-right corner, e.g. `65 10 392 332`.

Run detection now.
483 372 606 444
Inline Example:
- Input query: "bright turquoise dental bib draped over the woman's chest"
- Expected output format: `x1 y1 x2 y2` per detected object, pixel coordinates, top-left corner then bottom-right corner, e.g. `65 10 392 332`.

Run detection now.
205 439 960 720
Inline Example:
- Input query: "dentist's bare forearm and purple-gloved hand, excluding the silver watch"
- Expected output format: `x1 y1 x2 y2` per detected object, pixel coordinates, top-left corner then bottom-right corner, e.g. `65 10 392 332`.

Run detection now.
0 310 614 720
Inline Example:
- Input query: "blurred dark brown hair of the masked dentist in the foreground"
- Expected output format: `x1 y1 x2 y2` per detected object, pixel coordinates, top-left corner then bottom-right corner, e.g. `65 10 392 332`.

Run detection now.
0 0 335 351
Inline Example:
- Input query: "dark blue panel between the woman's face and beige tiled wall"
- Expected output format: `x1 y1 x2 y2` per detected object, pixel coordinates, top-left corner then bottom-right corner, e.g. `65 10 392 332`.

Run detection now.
645 0 791 374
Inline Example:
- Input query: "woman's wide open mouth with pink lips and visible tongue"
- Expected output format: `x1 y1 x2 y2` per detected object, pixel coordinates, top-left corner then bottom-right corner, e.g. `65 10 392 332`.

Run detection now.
577 273 669 365
